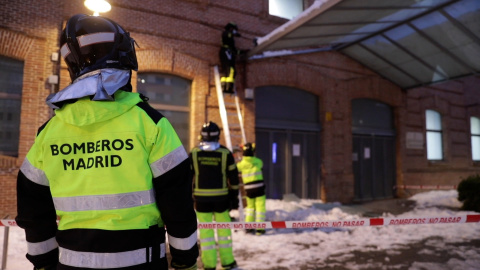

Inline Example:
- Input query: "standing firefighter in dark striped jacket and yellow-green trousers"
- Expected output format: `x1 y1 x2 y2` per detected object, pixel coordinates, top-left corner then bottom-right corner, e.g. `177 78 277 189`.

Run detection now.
190 122 239 269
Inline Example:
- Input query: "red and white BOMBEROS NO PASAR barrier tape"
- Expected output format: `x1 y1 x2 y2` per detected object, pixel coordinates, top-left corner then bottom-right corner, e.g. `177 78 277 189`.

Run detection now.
0 215 480 229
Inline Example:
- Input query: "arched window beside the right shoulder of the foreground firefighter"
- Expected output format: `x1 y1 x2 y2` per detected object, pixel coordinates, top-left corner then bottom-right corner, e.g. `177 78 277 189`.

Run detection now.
137 73 191 149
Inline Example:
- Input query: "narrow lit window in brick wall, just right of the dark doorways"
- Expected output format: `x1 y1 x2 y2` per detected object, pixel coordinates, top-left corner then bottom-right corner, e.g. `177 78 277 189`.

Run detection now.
425 110 443 160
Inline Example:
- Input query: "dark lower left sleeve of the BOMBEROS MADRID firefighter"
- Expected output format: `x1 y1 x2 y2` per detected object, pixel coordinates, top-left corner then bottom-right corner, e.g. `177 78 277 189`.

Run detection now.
15 170 58 268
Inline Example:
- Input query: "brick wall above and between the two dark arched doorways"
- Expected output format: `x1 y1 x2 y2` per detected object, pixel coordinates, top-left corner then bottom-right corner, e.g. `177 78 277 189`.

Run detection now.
245 52 403 202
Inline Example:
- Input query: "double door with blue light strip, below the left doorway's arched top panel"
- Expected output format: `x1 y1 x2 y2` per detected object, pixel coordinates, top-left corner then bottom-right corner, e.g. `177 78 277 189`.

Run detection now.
256 128 320 199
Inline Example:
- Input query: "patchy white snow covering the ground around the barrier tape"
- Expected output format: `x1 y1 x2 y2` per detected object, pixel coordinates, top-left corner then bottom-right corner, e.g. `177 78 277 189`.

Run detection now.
0 190 480 270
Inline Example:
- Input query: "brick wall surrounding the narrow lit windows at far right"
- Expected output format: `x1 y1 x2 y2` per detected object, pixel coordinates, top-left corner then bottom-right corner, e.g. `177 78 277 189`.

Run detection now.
403 77 480 191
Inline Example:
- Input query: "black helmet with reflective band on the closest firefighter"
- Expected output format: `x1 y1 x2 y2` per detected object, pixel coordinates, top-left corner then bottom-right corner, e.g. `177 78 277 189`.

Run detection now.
60 14 138 82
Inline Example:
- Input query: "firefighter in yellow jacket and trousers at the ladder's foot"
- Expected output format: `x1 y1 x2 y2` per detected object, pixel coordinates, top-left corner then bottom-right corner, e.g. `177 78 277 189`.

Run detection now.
237 143 266 235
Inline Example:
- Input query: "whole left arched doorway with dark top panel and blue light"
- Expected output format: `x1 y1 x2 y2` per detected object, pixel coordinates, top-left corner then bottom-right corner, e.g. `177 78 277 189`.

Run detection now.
255 86 320 199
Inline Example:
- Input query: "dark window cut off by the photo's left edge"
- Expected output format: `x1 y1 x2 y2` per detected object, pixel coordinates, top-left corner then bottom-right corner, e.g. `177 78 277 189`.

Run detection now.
0 56 23 157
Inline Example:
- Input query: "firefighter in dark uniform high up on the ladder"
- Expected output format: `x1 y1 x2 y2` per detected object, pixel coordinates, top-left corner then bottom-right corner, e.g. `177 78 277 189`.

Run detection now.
220 22 240 94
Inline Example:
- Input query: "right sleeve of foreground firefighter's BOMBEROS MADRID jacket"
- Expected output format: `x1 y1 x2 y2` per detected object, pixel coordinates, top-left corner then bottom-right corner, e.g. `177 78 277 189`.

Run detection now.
137 102 199 269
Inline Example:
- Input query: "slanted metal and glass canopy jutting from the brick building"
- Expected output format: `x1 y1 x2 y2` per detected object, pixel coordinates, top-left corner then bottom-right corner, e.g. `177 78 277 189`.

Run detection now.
249 0 480 89
